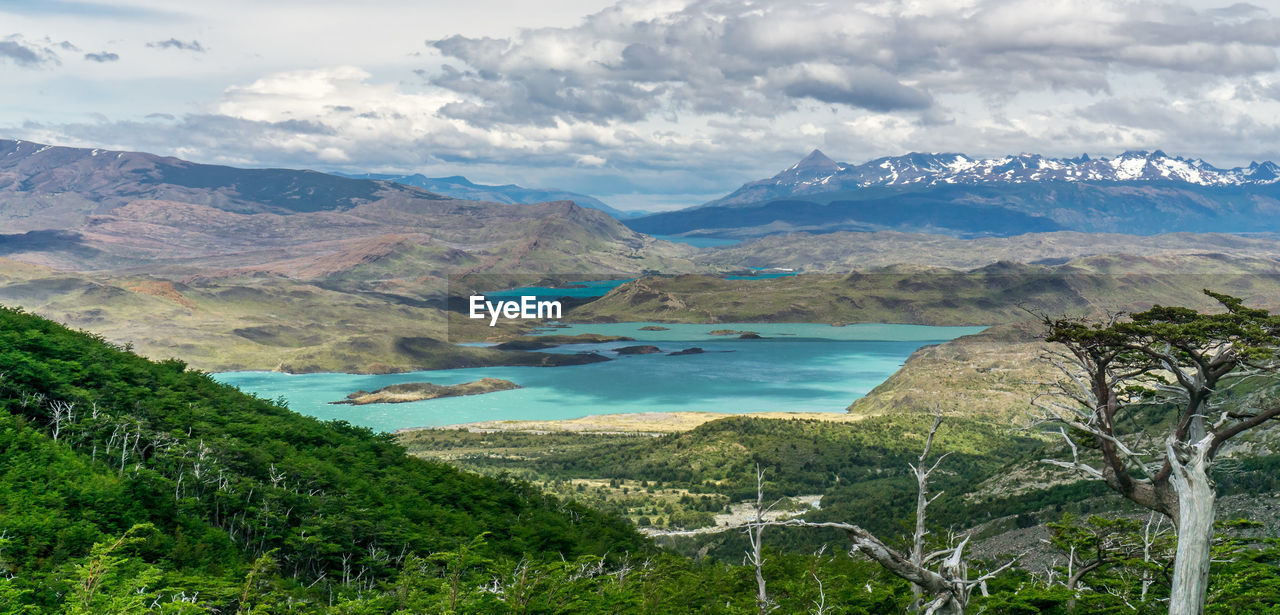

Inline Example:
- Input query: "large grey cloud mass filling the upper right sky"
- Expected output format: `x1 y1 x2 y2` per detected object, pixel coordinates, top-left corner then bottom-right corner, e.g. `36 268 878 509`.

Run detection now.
428 0 1280 126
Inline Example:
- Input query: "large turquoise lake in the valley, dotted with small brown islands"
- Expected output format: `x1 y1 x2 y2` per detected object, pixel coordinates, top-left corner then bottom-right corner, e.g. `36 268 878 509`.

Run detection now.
214 323 984 432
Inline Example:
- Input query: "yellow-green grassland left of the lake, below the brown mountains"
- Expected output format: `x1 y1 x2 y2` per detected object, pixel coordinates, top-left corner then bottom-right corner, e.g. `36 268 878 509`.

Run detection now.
0 259 584 373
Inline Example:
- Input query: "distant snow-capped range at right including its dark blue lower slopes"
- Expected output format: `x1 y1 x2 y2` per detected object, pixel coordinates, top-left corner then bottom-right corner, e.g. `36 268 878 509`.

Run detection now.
626 150 1280 238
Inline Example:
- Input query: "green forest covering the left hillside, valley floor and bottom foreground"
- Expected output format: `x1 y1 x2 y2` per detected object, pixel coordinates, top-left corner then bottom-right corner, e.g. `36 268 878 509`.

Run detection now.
0 304 1280 615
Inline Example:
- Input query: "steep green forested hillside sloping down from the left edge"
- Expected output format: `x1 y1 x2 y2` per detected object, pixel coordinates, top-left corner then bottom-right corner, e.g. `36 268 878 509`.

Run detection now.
0 304 648 614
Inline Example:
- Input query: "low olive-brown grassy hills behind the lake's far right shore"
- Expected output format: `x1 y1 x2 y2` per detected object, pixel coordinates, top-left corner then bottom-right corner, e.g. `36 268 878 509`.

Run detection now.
567 255 1280 325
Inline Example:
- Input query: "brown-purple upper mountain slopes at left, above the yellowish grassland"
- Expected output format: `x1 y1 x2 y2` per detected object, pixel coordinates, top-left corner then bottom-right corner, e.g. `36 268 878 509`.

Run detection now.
0 141 684 278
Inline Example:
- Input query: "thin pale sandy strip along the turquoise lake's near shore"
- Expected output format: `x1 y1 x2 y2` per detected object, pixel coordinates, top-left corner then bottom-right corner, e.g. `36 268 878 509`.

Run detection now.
397 413 863 436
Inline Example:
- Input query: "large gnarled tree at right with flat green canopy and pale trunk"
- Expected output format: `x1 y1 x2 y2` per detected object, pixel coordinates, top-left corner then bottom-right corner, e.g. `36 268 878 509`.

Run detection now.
1034 291 1280 615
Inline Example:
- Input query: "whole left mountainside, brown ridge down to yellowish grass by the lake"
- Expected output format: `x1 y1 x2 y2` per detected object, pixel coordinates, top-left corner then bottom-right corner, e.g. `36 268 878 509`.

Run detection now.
0 141 695 372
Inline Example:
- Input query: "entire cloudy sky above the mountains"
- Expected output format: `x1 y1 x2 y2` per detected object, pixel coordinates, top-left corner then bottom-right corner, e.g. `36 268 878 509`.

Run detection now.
0 0 1280 210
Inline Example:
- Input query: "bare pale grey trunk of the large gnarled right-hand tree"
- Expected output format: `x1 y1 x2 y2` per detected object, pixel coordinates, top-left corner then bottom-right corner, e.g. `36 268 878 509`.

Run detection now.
1167 437 1213 615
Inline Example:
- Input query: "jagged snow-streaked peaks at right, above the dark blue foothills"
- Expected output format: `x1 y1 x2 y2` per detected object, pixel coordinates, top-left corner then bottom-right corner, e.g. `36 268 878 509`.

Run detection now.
703 150 1280 206
